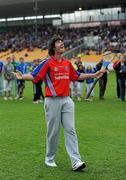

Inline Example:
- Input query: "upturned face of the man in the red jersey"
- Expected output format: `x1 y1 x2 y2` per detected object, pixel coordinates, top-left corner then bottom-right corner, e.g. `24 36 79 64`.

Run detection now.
54 40 65 54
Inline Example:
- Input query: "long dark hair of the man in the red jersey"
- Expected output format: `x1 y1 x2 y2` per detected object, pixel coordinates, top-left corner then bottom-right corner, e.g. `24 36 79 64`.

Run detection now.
48 35 63 56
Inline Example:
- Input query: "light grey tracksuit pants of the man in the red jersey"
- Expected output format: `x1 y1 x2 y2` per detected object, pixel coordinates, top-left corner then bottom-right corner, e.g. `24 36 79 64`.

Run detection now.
45 96 80 166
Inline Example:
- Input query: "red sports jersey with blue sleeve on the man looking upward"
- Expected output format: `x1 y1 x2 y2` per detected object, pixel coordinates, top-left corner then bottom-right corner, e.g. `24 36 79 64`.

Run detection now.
31 56 79 97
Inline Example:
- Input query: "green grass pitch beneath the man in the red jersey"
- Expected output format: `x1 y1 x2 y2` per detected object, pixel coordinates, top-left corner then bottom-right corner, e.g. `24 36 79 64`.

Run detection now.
0 73 126 180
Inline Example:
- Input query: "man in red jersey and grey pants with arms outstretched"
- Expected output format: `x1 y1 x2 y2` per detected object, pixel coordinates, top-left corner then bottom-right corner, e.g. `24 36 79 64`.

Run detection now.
15 36 104 171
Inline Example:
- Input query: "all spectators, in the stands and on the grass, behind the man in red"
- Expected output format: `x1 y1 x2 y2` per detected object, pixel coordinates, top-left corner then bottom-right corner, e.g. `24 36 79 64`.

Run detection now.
0 23 126 103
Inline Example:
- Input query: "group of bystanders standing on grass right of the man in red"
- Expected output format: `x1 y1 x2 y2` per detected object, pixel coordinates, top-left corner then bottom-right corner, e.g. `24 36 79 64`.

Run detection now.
70 53 126 101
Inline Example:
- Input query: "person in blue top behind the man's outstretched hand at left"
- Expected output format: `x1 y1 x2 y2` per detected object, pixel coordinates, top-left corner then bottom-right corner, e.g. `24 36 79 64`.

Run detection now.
16 57 28 100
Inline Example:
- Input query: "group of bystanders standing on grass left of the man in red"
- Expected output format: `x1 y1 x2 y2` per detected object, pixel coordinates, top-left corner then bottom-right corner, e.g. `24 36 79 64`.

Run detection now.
0 57 44 103
